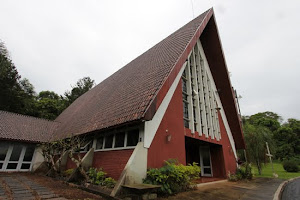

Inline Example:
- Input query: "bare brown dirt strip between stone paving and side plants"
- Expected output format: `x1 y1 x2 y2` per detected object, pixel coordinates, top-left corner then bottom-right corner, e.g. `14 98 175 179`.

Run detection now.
22 173 104 200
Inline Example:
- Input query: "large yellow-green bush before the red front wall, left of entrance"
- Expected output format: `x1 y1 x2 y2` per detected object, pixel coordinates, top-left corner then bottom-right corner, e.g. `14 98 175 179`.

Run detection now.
144 161 200 194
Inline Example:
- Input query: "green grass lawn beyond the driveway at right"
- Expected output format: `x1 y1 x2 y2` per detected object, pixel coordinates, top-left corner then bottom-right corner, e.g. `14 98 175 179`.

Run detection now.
252 162 300 179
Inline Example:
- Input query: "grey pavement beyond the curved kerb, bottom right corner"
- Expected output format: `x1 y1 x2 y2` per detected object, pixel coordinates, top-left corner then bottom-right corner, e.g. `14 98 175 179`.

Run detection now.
281 178 300 200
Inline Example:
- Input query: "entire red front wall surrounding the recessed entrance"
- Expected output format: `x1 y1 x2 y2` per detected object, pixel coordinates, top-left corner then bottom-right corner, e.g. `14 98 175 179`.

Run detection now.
148 77 236 178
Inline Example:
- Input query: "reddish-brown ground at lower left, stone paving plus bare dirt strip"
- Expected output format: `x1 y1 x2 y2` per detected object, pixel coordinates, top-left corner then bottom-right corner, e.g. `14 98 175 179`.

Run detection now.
0 173 103 200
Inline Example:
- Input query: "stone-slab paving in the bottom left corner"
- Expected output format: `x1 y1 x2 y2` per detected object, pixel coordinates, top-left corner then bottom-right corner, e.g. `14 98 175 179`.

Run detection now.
0 174 66 200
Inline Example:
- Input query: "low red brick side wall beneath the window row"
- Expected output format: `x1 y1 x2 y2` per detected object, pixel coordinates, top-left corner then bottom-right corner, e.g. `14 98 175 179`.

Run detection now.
93 149 134 180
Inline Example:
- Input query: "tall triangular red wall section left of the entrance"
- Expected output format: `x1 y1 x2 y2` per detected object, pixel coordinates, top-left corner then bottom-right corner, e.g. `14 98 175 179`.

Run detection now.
147 81 186 168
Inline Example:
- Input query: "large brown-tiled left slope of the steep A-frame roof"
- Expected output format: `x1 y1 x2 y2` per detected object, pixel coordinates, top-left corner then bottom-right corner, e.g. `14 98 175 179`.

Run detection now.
55 9 212 136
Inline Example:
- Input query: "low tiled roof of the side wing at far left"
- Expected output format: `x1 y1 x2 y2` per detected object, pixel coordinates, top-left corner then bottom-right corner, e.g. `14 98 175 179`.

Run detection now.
0 110 59 142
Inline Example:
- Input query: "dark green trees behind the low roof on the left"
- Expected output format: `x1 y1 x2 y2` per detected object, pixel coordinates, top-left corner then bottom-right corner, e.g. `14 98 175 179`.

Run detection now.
0 41 95 120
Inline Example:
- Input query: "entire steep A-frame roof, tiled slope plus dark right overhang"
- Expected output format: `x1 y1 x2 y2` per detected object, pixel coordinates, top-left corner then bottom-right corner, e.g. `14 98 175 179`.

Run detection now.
55 8 245 149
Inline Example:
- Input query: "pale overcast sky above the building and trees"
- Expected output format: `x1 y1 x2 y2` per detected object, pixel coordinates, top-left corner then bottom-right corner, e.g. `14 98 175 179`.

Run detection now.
0 0 300 119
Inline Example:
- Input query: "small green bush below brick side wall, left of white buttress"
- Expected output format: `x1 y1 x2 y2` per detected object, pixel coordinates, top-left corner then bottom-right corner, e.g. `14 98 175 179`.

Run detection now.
88 168 116 188
